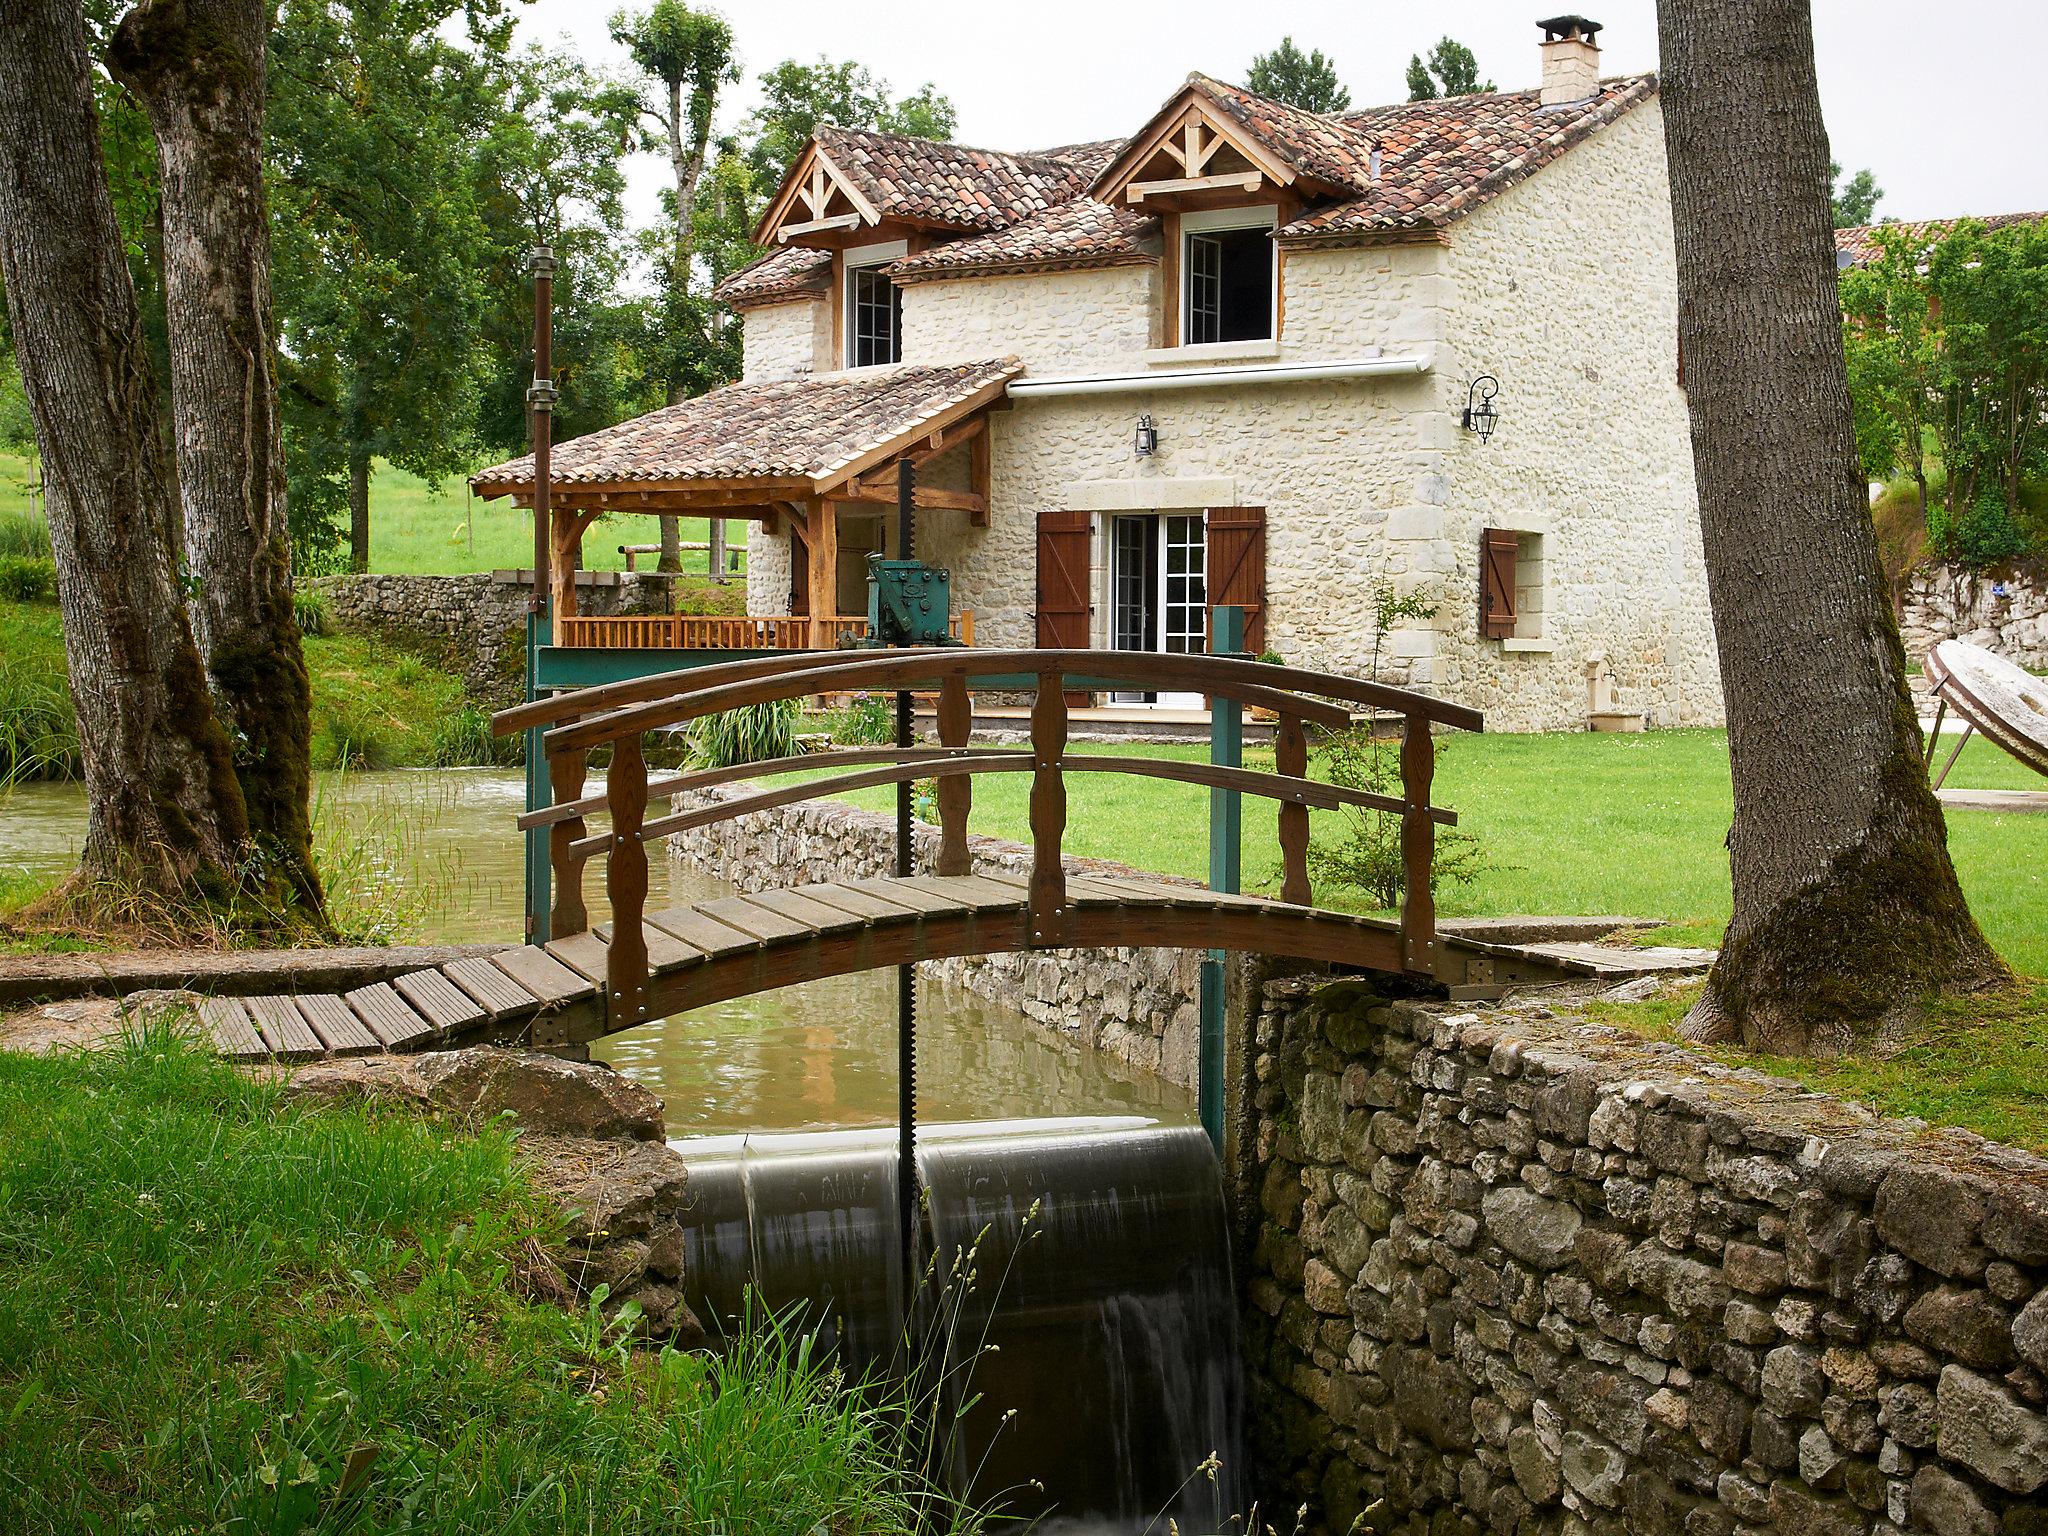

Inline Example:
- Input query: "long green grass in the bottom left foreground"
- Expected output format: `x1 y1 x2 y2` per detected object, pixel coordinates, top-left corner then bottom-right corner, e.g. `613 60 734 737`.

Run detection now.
0 1030 946 1536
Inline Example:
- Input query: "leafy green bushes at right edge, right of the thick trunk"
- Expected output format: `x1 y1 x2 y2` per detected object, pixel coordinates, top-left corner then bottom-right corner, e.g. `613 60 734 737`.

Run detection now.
1841 219 2048 567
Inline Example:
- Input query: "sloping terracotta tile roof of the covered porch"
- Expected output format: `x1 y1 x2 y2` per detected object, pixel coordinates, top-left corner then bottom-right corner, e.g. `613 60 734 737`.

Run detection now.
471 358 1024 496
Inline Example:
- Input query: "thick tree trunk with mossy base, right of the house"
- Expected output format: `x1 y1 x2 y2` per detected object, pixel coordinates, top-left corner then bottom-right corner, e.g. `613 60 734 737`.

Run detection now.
1657 0 2005 1053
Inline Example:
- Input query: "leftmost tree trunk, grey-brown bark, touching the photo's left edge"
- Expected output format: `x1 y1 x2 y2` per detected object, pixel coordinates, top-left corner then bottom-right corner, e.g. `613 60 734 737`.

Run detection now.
0 0 248 907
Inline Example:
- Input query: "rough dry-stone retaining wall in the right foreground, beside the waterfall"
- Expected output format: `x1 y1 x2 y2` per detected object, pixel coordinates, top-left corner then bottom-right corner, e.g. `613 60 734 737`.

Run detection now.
1243 981 2048 1536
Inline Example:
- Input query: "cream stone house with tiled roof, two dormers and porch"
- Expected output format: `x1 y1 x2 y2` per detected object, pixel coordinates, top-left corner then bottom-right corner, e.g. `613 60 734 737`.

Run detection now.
477 16 1720 729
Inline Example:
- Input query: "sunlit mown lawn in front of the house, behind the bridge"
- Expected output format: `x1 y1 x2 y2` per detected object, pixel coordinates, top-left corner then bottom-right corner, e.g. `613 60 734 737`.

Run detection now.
811 731 2048 975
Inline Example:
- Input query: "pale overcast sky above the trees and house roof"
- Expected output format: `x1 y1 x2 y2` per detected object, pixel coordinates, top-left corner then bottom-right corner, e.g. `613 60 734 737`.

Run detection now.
522 0 2048 231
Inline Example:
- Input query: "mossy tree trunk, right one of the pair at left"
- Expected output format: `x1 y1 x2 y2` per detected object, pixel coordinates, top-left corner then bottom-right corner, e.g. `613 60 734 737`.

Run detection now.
109 0 324 922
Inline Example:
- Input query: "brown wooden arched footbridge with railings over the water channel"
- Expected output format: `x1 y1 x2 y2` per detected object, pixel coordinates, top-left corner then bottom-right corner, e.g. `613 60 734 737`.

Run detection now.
205 649 1507 1057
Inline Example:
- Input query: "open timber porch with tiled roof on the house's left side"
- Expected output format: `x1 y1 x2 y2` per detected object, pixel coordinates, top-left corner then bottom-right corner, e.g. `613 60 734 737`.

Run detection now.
471 358 1022 651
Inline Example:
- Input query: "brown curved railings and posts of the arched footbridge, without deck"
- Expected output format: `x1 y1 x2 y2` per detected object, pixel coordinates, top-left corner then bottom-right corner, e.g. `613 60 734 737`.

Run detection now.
494 649 1483 1028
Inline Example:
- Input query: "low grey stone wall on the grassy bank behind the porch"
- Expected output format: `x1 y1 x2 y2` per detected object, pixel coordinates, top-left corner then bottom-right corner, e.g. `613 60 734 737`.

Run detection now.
311 571 670 705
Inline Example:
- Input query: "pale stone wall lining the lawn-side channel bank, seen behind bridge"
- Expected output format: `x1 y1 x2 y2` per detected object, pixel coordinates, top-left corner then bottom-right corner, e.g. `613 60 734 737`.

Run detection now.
668 788 1202 1087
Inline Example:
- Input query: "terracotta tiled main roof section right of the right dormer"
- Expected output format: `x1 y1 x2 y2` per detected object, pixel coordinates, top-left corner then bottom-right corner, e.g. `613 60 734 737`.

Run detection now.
1276 74 1657 244
